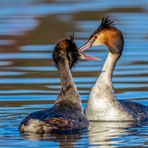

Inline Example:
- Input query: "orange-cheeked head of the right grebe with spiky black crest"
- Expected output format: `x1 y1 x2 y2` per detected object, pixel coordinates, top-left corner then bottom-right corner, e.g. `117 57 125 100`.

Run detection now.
80 17 124 54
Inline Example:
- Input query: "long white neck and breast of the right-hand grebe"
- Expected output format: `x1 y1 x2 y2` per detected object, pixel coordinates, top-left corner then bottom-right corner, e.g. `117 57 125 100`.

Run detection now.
86 52 120 120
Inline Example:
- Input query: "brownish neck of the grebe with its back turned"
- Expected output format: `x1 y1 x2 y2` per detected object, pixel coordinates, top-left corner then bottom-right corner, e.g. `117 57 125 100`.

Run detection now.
56 62 81 106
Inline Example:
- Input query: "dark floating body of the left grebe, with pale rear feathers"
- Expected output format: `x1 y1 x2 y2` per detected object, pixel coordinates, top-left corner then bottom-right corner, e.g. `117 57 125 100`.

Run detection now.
20 100 88 133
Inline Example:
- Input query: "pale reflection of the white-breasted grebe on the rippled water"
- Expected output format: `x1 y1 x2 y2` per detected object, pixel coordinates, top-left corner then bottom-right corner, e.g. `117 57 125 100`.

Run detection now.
88 121 147 148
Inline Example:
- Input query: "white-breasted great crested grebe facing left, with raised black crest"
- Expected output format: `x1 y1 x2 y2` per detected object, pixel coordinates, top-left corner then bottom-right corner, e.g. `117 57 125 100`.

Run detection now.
79 17 148 121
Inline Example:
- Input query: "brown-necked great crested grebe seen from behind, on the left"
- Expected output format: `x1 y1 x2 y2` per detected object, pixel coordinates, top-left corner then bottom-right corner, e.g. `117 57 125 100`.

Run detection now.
19 34 97 133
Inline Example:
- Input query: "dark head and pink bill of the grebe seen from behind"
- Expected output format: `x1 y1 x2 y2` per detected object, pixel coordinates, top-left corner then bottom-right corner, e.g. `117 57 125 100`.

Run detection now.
52 33 99 68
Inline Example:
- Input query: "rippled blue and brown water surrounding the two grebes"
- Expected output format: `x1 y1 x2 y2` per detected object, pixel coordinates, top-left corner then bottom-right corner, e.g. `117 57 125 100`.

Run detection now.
0 0 148 148
